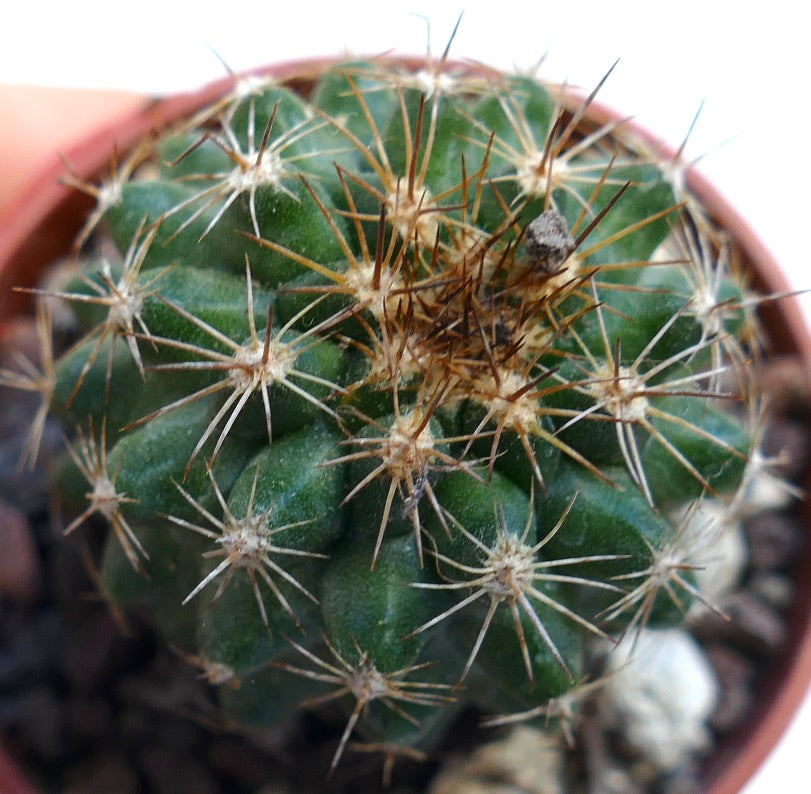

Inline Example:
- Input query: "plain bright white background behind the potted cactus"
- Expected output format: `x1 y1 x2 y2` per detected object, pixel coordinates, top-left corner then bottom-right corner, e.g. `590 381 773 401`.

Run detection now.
0 0 811 794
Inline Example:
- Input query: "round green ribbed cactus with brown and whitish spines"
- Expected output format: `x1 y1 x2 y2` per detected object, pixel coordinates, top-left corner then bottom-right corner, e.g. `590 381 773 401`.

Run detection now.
2 61 768 767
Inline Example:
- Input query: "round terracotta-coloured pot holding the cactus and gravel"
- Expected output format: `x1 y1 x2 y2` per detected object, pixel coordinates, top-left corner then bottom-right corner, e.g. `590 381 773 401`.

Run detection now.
0 58 811 794
